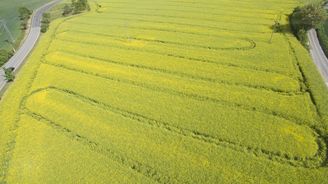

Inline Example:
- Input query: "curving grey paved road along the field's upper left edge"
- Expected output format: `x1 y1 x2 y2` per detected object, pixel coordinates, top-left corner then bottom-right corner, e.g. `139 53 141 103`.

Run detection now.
0 0 61 91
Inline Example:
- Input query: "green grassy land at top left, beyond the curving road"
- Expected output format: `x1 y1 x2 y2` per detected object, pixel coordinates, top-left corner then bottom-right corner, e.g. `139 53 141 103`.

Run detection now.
0 0 50 48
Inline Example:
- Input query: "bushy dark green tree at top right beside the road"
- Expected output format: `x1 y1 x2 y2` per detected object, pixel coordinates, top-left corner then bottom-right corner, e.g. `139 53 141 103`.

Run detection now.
290 4 328 47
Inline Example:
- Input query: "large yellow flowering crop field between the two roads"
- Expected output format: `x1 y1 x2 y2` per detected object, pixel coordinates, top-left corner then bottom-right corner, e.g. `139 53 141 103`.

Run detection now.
0 0 328 184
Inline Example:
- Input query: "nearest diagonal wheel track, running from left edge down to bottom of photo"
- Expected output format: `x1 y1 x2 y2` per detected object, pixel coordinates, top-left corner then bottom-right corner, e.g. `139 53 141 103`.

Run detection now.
25 109 181 183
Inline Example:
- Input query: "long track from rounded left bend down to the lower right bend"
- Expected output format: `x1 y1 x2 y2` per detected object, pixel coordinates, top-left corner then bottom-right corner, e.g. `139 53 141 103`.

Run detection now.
25 86 325 168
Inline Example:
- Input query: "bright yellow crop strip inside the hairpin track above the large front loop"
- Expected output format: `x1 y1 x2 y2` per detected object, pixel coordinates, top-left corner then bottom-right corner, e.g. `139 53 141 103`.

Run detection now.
45 52 315 121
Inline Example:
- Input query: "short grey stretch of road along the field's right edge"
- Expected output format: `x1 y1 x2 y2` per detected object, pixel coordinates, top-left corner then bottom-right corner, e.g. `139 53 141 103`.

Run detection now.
308 29 328 86
